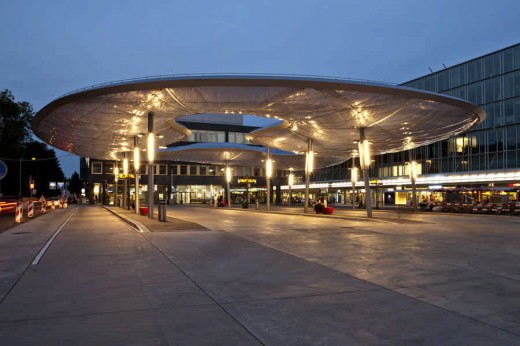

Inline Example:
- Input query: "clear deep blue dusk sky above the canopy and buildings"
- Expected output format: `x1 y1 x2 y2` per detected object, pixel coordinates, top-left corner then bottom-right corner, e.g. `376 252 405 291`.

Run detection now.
0 0 520 177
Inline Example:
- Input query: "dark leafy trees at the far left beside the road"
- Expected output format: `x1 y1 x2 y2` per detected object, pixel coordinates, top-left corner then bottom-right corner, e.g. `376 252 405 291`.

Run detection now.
0 90 64 196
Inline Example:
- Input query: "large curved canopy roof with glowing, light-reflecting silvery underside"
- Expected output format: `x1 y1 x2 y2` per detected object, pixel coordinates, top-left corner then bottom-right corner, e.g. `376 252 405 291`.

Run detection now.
33 76 485 167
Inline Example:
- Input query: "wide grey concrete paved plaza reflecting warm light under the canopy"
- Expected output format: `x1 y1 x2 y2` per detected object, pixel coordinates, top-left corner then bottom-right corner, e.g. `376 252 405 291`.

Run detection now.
0 206 520 345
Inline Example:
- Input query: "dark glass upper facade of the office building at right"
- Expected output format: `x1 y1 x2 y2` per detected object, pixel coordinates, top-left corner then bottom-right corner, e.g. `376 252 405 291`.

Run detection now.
371 44 520 178
